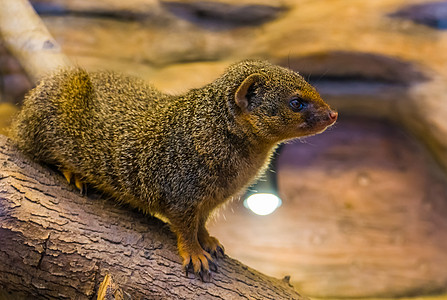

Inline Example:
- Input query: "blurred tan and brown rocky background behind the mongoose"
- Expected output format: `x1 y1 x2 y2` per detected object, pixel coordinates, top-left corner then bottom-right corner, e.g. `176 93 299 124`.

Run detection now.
0 0 447 299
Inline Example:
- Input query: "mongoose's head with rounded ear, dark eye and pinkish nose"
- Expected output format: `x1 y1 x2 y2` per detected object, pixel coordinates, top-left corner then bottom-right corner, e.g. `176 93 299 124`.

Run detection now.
228 60 338 142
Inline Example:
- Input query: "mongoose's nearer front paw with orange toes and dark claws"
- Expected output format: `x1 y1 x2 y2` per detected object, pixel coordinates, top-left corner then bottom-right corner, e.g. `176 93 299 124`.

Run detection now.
180 250 217 281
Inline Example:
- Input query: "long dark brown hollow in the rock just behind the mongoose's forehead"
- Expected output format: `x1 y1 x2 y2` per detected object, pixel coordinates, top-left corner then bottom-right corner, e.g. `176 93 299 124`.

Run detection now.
278 51 428 91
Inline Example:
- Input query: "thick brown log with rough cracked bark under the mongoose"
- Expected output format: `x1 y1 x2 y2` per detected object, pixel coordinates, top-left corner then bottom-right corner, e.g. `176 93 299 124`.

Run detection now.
0 136 305 299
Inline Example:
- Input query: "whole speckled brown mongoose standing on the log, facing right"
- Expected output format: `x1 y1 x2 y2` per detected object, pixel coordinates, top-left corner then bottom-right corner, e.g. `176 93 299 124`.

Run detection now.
13 60 337 278
